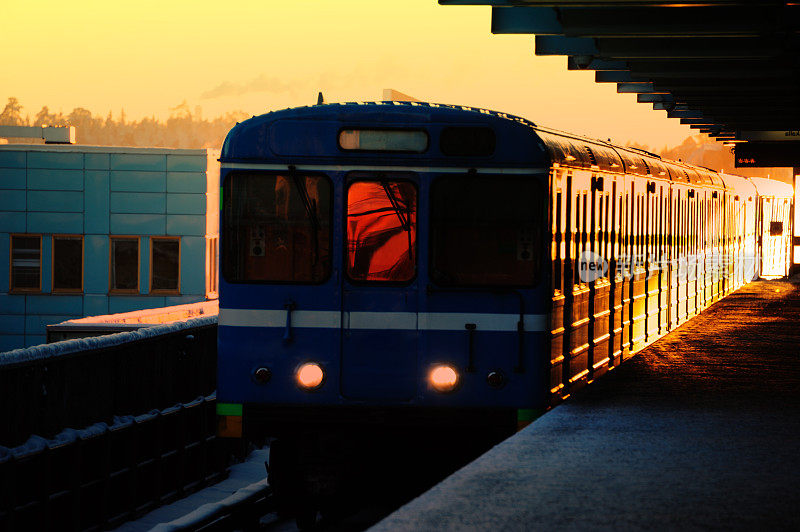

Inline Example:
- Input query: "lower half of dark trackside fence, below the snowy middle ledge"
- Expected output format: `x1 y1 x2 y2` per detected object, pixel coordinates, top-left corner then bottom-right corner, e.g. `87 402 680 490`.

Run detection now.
0 395 227 532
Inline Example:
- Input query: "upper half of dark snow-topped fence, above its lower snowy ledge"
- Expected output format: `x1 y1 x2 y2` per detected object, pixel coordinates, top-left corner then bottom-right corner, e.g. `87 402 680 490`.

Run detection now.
0 316 217 447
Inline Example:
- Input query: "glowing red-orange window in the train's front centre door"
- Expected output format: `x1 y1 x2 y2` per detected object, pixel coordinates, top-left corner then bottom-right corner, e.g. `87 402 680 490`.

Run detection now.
346 180 417 282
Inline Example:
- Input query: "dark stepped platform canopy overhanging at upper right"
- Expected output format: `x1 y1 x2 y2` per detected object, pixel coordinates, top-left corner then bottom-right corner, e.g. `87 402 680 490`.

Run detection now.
439 0 800 154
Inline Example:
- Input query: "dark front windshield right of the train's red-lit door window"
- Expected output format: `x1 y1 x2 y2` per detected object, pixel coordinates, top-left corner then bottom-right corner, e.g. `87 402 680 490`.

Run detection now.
430 175 546 286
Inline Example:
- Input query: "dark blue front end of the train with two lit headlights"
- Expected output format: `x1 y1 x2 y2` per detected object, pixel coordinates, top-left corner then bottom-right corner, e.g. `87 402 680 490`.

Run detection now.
218 103 550 512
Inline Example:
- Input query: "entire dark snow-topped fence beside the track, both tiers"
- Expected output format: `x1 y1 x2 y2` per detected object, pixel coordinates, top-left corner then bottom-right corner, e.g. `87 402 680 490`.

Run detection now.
0 317 228 532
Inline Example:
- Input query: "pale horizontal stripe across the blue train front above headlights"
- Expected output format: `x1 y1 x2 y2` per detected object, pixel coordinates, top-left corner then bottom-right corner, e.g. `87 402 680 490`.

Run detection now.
219 309 547 332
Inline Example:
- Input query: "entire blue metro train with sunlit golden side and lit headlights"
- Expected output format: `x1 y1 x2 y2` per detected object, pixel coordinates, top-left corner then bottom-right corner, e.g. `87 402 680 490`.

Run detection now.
218 102 792 520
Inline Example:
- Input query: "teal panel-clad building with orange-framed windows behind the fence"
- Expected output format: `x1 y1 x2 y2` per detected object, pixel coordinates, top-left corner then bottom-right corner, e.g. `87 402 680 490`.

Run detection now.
0 148 219 352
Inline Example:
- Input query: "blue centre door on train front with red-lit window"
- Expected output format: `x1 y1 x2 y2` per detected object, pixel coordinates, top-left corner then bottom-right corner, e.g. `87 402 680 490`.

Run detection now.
341 172 419 401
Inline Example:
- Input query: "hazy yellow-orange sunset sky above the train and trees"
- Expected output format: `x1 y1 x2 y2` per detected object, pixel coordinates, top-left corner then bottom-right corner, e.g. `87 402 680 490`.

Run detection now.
0 0 693 149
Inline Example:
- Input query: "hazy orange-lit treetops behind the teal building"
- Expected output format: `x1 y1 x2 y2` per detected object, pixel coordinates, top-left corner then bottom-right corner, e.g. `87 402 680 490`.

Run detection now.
0 97 249 149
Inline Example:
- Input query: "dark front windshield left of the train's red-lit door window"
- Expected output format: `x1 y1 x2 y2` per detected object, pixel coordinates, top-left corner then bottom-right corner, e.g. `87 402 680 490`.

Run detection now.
222 173 331 283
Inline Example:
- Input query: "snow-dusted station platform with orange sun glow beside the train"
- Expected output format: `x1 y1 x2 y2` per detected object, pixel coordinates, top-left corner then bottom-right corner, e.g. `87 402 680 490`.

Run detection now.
372 280 800 530
